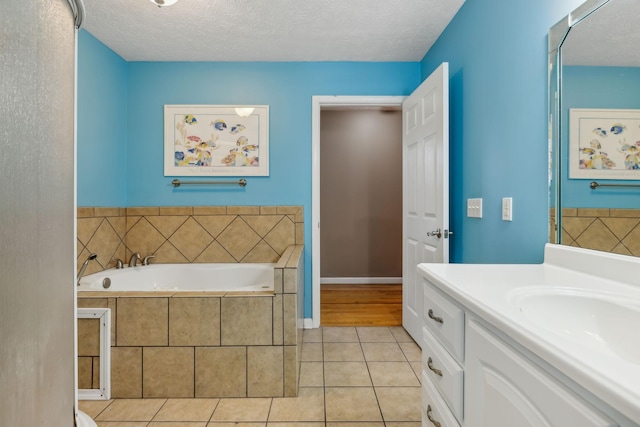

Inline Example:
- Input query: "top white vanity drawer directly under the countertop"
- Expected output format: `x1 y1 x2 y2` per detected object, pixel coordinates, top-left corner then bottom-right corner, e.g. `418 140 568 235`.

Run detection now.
422 278 464 362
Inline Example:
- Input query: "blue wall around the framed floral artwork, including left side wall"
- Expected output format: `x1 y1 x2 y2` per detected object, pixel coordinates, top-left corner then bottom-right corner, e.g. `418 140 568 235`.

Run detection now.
78 31 420 317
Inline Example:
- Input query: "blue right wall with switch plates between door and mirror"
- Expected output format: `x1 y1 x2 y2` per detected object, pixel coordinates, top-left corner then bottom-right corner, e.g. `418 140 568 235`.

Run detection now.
421 0 582 263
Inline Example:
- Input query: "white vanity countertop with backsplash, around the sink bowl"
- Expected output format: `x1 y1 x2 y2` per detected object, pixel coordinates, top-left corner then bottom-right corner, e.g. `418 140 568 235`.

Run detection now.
418 245 640 423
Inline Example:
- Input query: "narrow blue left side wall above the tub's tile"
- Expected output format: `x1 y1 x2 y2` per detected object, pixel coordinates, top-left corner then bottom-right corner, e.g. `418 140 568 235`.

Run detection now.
77 30 128 207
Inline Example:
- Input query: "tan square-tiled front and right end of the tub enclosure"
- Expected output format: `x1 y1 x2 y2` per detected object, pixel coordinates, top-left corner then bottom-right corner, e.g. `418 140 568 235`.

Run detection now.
78 245 304 398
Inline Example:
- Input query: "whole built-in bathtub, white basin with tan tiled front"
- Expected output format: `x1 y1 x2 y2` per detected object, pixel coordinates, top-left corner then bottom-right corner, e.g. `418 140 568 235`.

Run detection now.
78 245 304 398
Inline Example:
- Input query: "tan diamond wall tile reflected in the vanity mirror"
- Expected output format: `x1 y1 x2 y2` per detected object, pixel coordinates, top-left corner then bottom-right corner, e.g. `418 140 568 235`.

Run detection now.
549 208 640 256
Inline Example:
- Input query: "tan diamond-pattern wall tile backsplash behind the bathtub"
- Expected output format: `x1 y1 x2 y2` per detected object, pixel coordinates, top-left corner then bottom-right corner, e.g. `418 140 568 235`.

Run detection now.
77 206 304 274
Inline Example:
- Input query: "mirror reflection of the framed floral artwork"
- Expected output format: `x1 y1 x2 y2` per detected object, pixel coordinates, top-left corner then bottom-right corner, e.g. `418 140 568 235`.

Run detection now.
569 109 640 179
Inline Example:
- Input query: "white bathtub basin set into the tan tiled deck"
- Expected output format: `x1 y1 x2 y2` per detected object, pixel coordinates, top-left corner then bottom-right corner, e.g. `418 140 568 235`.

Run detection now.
78 263 275 292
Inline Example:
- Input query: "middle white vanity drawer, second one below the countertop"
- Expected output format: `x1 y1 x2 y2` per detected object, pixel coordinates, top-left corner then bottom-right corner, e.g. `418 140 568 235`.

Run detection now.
422 328 464 420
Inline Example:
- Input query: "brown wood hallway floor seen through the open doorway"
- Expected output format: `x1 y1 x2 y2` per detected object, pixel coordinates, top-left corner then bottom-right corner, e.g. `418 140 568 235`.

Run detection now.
320 284 402 326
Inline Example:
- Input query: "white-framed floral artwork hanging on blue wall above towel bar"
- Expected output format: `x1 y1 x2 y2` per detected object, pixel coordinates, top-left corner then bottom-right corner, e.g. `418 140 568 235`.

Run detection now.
164 105 269 176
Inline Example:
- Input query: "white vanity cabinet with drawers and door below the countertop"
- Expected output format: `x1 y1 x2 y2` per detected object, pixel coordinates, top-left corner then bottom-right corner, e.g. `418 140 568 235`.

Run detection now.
422 279 618 427
